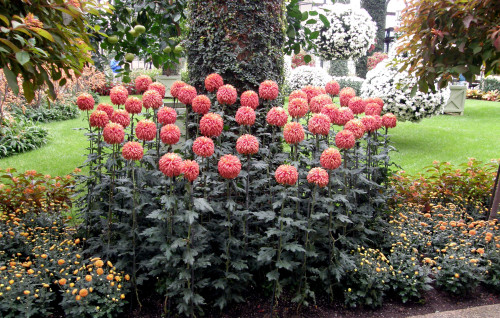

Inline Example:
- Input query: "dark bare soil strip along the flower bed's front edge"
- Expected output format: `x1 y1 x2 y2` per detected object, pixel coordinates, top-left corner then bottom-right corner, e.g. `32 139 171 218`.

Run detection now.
125 287 500 318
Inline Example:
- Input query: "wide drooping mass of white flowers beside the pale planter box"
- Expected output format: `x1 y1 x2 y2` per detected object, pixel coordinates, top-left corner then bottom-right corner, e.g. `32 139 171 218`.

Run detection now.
361 58 450 122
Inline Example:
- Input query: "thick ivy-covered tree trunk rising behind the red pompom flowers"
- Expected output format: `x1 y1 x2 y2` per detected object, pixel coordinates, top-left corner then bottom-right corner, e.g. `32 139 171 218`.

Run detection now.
185 0 285 94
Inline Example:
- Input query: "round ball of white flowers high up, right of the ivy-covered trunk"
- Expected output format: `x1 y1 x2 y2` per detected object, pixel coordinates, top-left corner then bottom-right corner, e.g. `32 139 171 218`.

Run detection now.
310 3 377 60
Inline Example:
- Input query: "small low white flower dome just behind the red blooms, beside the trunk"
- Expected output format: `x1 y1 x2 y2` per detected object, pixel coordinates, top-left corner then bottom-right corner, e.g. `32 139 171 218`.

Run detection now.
286 65 332 91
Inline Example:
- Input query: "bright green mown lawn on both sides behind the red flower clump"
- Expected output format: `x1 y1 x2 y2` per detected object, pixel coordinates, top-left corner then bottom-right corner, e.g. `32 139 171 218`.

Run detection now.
0 97 500 175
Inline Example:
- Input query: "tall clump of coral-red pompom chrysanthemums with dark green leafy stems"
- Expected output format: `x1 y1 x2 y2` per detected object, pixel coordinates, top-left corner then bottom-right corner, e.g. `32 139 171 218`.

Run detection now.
80 74 396 316
